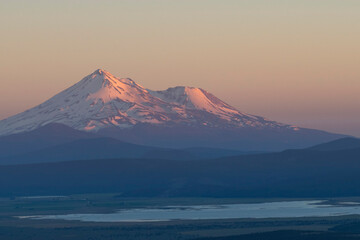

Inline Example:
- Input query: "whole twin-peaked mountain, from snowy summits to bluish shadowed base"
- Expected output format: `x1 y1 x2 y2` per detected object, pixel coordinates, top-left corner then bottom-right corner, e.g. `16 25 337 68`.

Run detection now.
0 69 342 151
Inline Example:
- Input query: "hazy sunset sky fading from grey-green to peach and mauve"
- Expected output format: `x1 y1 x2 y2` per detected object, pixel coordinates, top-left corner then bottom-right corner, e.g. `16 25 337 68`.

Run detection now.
0 0 360 136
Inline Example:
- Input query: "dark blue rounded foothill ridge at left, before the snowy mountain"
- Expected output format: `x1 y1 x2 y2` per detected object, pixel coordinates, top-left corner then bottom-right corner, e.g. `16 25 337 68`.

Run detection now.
0 124 254 165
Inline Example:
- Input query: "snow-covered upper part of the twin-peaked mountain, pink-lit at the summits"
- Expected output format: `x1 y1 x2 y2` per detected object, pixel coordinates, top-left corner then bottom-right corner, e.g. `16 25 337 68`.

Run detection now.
0 69 298 135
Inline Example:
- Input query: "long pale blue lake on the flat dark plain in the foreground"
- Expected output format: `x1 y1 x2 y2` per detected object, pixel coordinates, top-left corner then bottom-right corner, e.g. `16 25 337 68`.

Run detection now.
20 200 360 222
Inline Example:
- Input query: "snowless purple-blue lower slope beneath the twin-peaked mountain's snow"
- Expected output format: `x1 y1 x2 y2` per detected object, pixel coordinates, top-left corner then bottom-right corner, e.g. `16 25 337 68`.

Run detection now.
97 124 343 152
